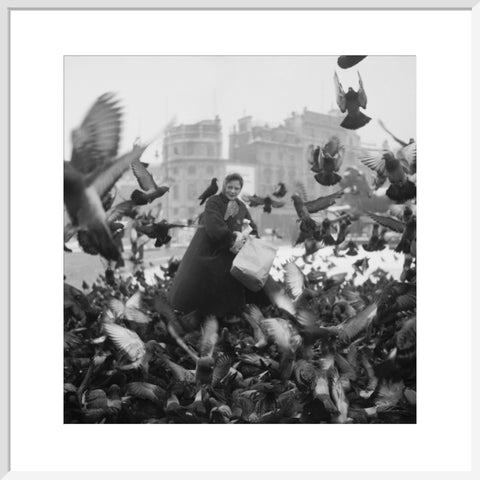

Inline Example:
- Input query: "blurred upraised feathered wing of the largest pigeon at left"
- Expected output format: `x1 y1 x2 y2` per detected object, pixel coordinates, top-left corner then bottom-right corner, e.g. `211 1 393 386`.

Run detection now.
71 93 122 174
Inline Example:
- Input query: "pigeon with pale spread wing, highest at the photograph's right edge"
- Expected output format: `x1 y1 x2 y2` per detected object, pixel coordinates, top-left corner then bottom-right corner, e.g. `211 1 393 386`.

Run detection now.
360 150 417 203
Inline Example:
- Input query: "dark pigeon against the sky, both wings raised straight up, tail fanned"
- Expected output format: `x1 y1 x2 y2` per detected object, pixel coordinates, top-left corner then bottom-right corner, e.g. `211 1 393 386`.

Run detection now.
334 72 371 130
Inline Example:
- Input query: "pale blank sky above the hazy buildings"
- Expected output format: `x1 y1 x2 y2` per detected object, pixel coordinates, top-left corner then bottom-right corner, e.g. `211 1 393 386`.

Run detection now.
64 56 416 163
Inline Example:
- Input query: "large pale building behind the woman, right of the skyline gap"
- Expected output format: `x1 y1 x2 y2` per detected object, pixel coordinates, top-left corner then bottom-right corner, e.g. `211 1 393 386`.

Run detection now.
229 108 361 239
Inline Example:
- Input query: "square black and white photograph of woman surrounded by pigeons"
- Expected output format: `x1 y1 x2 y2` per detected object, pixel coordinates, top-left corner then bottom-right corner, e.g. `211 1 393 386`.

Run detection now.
63 52 421 428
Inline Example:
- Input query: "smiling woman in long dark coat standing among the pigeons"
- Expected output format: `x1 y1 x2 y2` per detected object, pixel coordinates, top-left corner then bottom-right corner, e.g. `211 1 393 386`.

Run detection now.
169 173 268 317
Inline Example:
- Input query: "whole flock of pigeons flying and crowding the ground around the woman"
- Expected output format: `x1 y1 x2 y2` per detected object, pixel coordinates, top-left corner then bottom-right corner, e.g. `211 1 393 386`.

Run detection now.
64 56 416 423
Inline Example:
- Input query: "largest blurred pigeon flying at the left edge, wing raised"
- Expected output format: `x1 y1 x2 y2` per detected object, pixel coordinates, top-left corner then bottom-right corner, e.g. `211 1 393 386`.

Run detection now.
64 94 146 261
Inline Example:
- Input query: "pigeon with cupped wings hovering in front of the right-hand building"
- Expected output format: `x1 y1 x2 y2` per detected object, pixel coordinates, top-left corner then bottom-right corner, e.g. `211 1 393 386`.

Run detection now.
307 136 345 186
